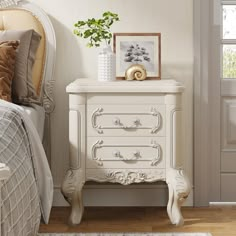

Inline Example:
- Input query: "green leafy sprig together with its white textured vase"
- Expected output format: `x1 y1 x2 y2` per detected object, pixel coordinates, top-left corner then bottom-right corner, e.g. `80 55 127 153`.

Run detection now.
74 11 119 81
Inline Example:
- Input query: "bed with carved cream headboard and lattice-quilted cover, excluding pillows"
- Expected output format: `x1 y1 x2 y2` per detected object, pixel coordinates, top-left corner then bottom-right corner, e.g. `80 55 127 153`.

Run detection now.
0 0 56 236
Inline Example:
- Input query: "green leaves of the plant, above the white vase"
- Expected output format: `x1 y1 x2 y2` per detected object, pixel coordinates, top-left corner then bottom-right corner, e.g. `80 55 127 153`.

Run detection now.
74 11 119 47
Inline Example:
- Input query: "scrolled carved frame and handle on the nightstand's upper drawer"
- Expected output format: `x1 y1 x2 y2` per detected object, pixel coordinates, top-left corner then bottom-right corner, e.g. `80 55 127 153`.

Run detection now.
91 107 162 134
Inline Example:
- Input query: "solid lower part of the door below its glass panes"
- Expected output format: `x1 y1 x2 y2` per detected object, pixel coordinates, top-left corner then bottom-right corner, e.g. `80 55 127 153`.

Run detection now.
220 96 236 199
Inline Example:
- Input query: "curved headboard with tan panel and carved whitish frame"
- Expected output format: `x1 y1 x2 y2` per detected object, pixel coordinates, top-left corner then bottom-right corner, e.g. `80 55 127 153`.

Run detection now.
0 1 56 113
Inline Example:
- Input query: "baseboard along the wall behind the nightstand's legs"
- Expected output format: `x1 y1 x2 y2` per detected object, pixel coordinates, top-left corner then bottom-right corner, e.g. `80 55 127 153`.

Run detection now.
53 184 193 206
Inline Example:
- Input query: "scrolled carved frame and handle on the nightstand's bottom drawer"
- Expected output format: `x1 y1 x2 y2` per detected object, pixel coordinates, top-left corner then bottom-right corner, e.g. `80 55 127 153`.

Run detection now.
91 140 162 167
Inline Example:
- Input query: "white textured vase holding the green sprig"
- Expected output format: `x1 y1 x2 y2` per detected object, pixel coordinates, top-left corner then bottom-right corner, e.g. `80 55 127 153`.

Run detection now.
98 45 116 81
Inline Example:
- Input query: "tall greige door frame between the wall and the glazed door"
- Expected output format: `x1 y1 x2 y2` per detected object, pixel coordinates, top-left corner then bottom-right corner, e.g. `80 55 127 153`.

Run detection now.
193 0 221 206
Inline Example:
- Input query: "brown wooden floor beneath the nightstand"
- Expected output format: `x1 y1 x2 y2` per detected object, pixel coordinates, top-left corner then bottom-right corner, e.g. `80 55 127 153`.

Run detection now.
40 207 236 236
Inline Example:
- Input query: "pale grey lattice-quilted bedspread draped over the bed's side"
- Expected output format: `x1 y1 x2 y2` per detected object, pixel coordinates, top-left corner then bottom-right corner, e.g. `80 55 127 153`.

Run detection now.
0 100 53 236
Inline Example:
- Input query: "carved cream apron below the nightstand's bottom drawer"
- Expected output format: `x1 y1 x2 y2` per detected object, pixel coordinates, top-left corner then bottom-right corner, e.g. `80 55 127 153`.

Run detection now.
86 169 166 185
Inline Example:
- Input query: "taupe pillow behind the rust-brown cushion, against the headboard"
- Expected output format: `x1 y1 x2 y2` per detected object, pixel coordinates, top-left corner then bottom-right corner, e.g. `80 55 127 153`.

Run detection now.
0 29 41 104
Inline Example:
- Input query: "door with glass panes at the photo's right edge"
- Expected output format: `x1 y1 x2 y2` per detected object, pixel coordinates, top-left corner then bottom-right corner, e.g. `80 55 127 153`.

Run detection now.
220 0 236 202
